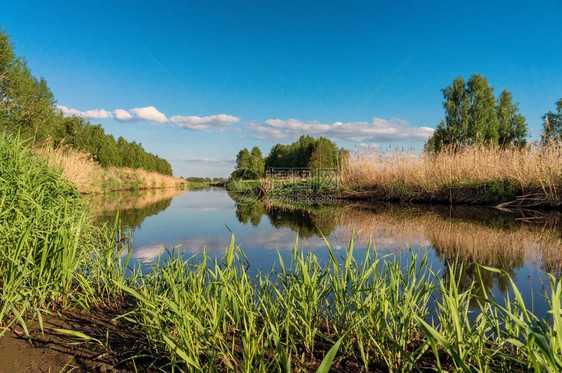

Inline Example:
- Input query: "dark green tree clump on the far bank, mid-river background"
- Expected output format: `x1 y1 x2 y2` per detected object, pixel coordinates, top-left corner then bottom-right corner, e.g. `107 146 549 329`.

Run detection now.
231 136 349 179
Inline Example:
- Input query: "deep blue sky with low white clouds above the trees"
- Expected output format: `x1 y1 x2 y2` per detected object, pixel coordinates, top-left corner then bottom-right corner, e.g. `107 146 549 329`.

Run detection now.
0 1 562 176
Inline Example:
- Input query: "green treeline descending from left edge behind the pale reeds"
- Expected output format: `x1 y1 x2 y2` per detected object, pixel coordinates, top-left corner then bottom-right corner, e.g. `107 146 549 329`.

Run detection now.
0 29 172 175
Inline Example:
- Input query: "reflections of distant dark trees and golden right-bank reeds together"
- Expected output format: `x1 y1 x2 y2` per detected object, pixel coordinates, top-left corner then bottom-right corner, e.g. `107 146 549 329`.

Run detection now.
236 201 562 295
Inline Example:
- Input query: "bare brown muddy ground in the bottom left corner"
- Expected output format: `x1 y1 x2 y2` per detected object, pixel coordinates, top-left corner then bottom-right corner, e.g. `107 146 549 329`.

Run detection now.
0 305 164 373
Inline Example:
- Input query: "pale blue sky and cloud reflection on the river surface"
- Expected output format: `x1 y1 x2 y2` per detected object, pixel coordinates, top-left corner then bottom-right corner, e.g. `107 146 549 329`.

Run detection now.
101 189 549 313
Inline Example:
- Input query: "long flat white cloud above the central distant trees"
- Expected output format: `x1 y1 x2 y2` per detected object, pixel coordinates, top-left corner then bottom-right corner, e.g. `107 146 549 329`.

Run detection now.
245 118 434 143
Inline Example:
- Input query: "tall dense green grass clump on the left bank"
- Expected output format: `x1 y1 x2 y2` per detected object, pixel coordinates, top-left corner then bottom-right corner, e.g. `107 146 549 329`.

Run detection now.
0 135 132 335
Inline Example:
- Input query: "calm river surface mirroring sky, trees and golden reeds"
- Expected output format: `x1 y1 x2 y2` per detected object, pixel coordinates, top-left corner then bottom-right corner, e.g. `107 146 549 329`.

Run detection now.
92 188 562 314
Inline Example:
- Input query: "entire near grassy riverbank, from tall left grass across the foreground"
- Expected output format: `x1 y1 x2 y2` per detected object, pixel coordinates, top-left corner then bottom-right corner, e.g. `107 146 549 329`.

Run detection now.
0 137 562 372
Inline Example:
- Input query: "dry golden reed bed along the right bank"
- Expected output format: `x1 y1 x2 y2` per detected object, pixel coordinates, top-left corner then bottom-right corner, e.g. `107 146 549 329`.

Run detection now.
341 143 562 206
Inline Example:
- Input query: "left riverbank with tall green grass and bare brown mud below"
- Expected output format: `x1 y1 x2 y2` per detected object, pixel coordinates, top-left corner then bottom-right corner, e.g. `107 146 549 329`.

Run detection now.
0 134 155 372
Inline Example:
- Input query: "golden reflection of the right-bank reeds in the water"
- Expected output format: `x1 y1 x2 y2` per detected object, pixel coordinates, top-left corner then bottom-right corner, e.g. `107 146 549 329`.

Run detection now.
339 205 562 295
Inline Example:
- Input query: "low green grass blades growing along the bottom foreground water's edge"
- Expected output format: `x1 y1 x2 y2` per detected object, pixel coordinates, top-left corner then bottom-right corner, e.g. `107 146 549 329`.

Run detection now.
110 238 562 372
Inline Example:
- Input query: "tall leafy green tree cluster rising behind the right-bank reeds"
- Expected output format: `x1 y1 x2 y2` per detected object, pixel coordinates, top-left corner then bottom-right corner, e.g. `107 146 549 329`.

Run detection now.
425 74 527 152
